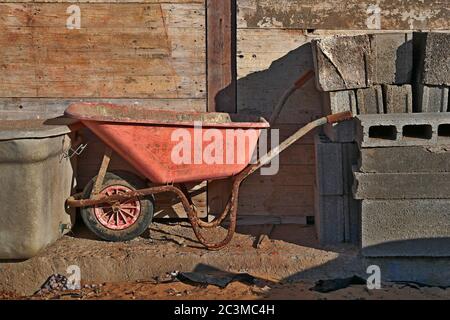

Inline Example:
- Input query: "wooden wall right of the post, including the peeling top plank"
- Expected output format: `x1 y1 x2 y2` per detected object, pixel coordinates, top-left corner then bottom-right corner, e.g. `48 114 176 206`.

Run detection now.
237 0 450 221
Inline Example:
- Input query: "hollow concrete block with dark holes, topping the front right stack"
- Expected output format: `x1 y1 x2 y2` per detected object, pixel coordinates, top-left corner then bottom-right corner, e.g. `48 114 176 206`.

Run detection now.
356 112 450 148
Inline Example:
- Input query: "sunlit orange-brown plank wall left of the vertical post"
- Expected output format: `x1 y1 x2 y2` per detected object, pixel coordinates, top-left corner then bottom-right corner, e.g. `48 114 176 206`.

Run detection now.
0 0 206 216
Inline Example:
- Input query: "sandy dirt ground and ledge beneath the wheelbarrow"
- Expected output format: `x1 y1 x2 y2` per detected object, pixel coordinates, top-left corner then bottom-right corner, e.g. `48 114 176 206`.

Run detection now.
0 222 450 300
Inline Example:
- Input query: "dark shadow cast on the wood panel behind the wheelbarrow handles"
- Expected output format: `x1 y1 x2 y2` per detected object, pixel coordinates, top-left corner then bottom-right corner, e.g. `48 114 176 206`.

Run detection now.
212 43 322 242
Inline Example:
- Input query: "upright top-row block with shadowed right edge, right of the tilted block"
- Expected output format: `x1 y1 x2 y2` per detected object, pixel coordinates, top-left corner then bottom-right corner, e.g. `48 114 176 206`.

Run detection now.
369 33 413 84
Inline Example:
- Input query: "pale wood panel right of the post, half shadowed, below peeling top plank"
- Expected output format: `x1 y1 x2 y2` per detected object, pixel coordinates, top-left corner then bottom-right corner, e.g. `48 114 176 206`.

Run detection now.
237 29 321 217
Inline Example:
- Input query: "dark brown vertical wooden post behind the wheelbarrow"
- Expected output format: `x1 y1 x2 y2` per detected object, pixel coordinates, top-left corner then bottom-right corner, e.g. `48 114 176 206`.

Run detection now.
206 0 237 215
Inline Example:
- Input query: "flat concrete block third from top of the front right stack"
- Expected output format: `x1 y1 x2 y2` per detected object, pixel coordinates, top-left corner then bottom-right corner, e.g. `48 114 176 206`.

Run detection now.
353 172 450 200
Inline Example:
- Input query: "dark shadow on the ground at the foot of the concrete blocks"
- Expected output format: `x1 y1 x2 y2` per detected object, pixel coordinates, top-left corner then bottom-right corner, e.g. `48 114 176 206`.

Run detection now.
283 238 450 287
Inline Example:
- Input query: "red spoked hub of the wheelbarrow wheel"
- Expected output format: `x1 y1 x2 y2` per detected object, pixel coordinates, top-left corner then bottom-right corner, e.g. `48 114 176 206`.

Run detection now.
94 185 141 230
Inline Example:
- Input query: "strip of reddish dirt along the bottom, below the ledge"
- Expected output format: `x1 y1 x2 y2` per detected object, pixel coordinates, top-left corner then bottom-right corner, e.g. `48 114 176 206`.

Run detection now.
0 281 450 300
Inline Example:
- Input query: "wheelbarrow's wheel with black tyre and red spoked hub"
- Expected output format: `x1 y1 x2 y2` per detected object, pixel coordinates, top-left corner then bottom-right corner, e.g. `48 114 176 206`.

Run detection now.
81 172 154 242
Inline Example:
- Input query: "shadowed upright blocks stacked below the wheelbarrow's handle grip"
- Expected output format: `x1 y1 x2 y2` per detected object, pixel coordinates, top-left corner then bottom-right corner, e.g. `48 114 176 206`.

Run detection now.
315 134 360 245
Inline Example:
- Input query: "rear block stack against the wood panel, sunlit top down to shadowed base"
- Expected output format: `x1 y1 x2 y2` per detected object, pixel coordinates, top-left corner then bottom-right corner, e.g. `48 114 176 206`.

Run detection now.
312 33 413 245
